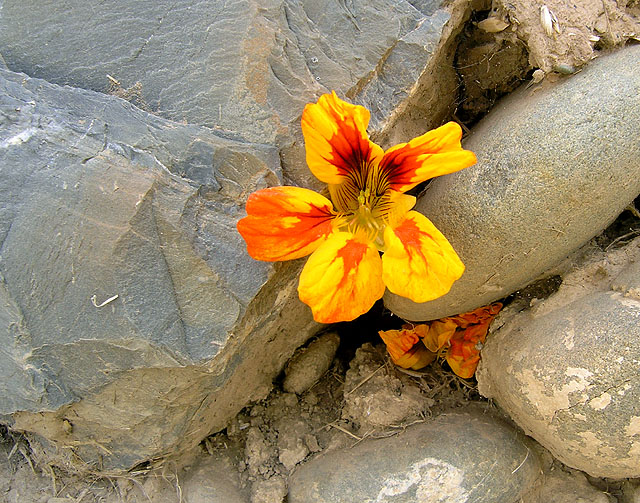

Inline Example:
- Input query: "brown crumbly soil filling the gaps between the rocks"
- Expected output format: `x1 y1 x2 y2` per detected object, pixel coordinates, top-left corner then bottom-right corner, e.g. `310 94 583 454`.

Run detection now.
0 0 640 503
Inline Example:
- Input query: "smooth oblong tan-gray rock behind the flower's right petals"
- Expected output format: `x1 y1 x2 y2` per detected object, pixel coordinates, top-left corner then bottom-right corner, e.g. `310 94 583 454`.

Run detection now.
385 47 640 320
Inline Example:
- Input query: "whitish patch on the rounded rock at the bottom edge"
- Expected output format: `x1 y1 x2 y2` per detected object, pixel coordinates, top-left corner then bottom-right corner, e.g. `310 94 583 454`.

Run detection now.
367 458 469 503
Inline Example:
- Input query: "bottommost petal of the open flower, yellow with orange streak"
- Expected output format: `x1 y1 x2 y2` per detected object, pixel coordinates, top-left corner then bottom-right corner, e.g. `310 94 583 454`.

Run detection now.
298 232 384 323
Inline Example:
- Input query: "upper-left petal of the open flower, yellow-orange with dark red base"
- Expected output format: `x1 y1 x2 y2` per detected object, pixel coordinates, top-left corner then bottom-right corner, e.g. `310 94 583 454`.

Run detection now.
302 92 382 184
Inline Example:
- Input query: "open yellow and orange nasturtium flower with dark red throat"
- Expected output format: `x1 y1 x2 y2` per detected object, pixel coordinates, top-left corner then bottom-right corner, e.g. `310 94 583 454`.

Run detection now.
238 92 476 323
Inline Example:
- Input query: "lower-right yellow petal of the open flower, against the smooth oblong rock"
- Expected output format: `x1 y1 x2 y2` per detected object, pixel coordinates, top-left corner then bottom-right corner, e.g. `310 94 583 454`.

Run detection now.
382 211 464 302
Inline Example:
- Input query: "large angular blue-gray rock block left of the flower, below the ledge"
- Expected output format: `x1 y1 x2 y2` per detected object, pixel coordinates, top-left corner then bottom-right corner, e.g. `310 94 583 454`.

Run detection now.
0 70 317 472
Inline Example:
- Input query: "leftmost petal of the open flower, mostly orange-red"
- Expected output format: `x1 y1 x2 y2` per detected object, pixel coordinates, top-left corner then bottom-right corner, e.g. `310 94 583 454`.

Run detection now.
237 187 333 262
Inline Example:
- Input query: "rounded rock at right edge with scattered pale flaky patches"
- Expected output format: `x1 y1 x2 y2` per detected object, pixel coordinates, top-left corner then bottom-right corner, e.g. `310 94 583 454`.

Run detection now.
476 240 640 478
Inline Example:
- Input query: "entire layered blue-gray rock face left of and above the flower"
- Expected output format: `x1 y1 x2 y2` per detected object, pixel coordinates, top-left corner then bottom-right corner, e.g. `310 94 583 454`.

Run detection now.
0 1 461 473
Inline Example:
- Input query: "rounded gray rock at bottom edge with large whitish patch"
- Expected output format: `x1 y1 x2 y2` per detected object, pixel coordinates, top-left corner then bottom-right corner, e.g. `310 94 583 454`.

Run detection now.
288 408 540 503
